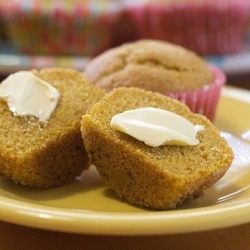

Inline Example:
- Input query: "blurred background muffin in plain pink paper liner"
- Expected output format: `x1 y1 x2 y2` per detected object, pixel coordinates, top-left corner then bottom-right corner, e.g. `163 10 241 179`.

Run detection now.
124 0 249 55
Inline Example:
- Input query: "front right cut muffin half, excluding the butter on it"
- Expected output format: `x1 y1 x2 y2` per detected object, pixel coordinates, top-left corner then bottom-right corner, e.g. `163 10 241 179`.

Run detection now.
81 87 233 210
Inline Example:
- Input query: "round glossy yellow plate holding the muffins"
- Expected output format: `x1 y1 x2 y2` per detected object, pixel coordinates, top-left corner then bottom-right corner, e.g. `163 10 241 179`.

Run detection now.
0 87 250 235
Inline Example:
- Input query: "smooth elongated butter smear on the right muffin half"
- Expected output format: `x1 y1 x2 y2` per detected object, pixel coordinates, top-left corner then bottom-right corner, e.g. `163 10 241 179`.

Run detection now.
110 107 204 147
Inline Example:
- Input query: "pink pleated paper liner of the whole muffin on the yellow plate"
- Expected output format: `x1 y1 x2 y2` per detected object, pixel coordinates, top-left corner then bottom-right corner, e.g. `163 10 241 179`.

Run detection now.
166 64 226 121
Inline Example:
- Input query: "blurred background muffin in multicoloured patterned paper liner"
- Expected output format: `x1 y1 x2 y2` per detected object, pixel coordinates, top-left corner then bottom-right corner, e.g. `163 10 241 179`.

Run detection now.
2 0 121 56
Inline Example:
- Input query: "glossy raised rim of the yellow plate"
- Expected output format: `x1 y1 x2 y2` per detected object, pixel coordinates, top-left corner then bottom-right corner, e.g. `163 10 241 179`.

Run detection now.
0 86 250 235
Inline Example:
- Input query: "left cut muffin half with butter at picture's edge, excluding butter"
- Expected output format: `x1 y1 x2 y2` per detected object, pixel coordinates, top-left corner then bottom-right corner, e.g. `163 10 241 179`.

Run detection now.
0 68 104 188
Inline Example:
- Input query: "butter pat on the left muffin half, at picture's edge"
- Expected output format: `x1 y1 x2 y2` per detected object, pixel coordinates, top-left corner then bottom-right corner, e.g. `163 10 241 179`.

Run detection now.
0 71 59 123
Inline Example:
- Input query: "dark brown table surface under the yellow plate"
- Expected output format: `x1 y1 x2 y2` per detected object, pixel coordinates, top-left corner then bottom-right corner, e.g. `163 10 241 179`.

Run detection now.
0 71 250 250
